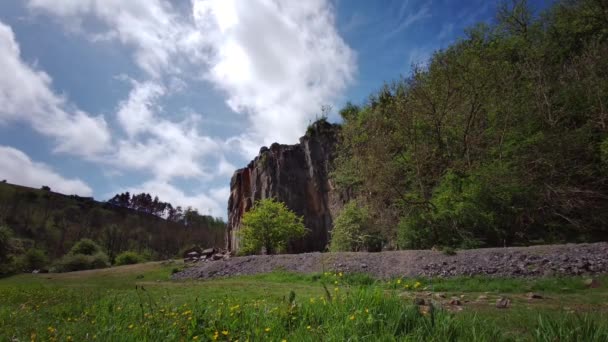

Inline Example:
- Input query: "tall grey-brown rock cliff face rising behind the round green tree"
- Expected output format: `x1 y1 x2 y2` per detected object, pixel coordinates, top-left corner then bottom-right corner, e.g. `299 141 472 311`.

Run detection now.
226 120 346 253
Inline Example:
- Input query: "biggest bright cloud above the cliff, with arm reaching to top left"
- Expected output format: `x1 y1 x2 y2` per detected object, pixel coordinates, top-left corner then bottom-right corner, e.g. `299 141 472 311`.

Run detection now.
28 0 356 157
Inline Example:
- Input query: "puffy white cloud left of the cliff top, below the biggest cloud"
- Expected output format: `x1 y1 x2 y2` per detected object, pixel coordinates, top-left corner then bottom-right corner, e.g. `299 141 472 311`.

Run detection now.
110 81 226 181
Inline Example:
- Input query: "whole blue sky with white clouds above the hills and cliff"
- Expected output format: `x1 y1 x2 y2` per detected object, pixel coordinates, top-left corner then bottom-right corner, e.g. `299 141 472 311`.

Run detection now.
0 0 547 218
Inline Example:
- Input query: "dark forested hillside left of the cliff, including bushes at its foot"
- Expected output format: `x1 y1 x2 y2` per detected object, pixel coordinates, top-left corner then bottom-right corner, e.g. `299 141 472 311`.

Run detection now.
0 182 225 275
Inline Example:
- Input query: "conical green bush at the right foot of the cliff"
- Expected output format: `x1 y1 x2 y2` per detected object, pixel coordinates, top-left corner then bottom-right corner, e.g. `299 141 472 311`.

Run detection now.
329 201 382 252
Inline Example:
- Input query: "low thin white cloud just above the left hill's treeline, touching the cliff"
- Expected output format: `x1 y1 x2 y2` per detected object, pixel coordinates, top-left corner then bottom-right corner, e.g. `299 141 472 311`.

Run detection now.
127 180 228 218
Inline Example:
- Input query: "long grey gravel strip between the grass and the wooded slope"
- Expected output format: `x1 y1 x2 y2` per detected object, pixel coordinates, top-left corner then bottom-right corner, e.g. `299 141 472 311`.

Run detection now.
173 242 608 279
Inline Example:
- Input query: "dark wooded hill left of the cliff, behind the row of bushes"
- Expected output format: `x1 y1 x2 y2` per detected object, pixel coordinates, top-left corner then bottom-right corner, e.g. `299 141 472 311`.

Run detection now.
0 182 225 260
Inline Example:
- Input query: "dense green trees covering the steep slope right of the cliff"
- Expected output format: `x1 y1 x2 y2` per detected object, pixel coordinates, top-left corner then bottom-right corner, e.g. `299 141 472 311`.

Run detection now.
333 0 608 248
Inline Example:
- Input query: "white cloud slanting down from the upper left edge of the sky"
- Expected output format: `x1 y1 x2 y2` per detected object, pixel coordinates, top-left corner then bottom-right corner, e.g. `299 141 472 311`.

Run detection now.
0 22 110 156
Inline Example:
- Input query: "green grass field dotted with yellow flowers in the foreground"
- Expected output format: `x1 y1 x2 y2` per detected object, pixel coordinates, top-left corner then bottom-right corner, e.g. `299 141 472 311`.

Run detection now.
0 263 608 341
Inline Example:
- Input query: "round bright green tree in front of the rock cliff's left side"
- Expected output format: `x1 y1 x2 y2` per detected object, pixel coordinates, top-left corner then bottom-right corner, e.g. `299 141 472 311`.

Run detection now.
239 198 307 254
